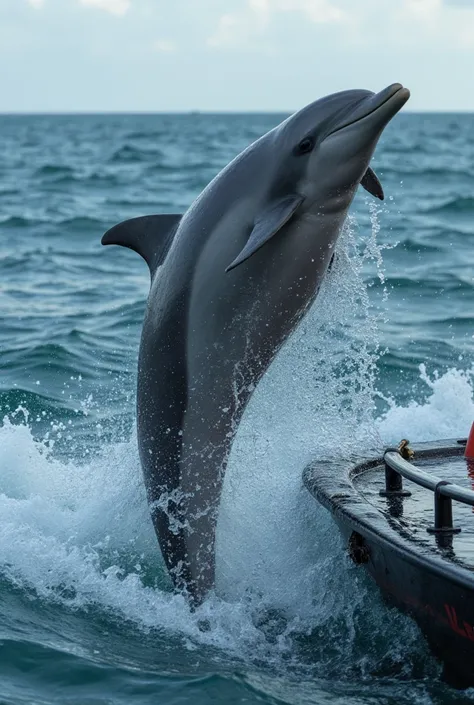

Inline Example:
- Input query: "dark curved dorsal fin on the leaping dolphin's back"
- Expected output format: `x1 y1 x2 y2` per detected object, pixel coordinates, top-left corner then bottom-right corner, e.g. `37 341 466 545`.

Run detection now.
102 214 182 278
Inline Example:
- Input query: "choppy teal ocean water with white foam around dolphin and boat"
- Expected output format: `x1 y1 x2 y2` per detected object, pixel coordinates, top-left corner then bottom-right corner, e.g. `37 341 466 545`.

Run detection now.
0 113 474 705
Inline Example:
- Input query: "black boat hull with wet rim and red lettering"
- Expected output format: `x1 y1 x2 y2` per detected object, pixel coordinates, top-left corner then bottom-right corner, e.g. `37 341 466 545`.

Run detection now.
303 441 474 688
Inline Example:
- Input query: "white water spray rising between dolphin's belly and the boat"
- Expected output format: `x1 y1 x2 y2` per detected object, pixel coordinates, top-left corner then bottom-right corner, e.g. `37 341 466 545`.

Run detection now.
216 216 390 619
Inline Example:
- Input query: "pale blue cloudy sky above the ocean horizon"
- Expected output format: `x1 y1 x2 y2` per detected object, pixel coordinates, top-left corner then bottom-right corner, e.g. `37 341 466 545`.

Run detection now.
0 0 474 112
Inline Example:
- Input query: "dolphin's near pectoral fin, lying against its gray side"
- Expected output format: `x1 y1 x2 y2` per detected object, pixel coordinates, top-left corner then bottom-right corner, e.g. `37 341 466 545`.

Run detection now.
225 194 304 272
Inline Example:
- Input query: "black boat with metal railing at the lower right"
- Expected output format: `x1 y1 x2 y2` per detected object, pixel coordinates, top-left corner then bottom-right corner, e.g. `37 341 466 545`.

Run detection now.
303 424 474 688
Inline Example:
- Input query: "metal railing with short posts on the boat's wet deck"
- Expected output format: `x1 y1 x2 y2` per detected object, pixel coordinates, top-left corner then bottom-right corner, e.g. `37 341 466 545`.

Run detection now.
380 448 474 535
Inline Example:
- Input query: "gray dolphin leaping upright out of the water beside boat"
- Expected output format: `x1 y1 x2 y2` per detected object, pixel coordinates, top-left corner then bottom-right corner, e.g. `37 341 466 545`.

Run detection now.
102 83 410 606
